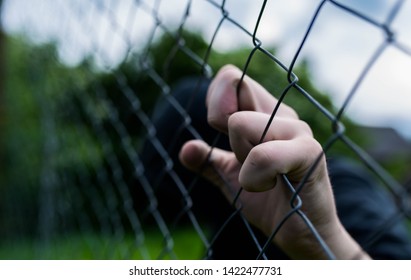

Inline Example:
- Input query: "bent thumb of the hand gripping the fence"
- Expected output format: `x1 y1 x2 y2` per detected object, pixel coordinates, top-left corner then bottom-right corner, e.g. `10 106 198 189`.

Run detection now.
179 140 241 196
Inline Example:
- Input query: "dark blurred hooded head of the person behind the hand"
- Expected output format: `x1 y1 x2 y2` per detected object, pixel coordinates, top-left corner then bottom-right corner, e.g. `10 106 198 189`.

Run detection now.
140 77 232 226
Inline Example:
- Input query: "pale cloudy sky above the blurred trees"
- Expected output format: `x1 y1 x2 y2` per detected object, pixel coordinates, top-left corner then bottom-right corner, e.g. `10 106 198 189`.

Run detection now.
2 0 411 139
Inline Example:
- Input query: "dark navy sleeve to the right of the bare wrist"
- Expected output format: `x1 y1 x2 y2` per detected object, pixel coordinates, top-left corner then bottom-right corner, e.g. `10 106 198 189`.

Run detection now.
328 160 411 259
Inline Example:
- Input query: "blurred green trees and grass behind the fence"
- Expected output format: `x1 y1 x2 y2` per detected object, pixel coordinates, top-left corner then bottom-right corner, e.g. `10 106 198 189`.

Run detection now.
0 2 410 259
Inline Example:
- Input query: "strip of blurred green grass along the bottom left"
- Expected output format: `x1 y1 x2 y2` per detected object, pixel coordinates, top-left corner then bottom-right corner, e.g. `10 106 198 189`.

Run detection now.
0 229 205 260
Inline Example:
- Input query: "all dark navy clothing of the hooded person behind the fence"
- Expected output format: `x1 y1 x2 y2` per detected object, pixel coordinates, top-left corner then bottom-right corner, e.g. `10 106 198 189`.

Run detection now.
142 78 411 259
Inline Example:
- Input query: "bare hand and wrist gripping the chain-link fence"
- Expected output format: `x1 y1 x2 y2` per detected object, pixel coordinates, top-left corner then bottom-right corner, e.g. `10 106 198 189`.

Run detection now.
179 65 369 259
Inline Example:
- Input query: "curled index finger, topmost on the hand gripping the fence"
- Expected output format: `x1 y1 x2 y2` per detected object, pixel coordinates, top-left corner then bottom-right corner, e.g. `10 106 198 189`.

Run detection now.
206 65 298 133
